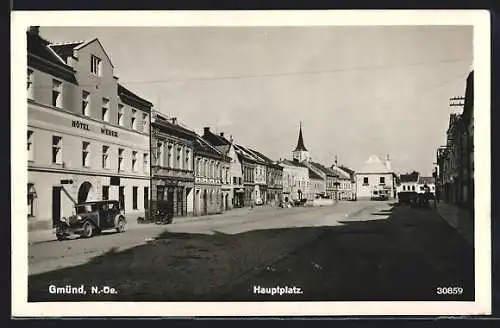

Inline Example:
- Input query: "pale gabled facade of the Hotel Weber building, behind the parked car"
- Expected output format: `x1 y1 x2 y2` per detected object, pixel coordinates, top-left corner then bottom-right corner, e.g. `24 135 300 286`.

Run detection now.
27 32 151 229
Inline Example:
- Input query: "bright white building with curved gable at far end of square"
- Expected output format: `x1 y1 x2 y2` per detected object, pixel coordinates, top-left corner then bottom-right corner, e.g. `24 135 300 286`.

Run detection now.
356 155 395 199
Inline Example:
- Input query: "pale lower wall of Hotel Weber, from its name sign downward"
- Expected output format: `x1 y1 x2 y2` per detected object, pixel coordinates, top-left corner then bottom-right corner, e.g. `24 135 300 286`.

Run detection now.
27 101 150 228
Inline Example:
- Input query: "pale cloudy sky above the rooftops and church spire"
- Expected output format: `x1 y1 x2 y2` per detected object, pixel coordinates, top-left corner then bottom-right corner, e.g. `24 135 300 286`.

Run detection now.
40 26 473 175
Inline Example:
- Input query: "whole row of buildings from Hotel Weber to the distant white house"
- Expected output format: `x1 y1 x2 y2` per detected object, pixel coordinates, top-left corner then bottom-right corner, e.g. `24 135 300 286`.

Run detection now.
27 27 400 229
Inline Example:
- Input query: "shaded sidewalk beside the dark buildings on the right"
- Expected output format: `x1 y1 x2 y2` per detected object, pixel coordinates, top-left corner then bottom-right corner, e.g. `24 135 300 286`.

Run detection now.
436 202 474 245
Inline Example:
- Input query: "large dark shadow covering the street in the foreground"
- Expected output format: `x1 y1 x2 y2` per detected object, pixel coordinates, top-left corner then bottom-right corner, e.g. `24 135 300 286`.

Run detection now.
28 206 474 302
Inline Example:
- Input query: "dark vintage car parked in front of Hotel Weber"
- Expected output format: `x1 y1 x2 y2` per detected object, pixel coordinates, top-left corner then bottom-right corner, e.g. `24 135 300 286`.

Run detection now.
56 200 127 240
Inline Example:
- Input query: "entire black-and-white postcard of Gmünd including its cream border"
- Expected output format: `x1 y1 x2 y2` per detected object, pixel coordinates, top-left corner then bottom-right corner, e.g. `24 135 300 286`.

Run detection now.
11 11 491 316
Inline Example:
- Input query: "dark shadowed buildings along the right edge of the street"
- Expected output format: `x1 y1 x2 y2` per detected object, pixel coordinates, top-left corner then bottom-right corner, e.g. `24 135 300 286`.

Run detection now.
434 70 474 211
